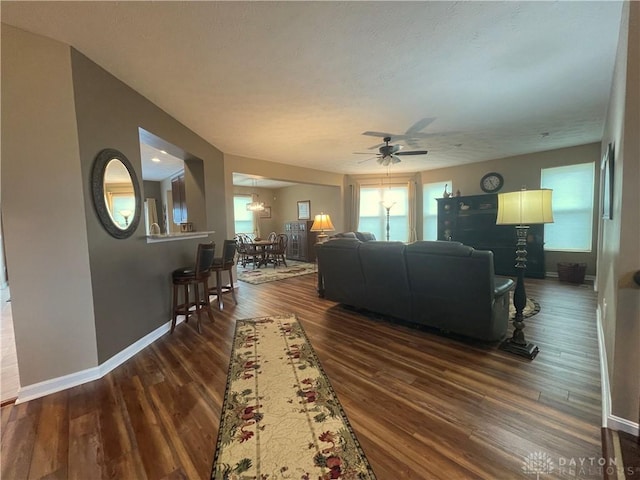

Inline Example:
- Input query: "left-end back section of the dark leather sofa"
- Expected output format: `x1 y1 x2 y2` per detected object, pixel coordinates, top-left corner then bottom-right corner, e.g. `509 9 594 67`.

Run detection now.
316 238 365 307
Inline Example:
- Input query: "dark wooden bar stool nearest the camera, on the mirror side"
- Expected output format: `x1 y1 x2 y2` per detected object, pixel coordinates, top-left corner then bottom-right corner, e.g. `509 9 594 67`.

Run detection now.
171 242 216 333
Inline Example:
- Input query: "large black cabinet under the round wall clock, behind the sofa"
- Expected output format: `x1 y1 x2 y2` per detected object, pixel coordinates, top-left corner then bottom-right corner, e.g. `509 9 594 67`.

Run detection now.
437 194 545 278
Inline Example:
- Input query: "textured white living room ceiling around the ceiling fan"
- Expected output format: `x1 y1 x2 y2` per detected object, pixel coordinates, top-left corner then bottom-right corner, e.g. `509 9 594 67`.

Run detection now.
0 1 621 173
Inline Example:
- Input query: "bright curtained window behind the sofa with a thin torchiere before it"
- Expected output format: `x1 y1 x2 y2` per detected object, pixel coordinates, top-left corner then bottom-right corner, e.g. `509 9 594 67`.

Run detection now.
358 185 409 242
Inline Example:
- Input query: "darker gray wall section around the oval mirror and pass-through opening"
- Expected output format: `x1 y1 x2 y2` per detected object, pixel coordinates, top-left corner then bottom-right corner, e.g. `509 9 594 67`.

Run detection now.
71 49 226 363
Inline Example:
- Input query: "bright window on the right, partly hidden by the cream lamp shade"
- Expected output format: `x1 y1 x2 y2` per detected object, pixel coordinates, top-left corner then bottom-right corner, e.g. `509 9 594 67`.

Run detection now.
540 163 595 252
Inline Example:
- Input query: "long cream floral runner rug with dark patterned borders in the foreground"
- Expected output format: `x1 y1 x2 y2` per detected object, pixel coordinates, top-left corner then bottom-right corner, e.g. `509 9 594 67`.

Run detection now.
211 314 375 480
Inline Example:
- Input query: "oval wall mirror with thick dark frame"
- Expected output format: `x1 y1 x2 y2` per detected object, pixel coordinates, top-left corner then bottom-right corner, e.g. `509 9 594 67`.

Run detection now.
91 148 141 238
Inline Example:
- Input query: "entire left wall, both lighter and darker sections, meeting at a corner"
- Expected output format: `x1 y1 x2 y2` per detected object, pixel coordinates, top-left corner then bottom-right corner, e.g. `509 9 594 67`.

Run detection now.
2 21 226 387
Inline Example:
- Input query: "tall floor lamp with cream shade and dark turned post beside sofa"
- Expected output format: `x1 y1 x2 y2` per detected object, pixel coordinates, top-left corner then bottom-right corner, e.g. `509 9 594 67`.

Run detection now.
496 189 553 360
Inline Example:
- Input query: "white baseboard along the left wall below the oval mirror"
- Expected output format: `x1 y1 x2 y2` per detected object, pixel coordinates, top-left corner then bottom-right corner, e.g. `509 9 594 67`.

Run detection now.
16 317 184 404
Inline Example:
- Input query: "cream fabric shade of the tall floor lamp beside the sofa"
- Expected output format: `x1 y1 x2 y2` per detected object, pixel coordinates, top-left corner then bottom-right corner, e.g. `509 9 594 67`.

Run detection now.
496 188 553 225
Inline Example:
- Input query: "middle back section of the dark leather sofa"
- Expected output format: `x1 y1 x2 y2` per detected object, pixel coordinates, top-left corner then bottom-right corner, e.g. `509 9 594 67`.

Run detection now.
359 242 411 319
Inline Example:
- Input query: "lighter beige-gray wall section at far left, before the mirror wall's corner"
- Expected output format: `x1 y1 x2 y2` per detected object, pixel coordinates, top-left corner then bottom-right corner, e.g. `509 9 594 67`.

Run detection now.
2 25 98 386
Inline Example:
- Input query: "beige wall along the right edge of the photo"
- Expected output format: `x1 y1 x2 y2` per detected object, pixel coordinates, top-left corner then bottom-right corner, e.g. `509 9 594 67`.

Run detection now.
597 2 640 428
